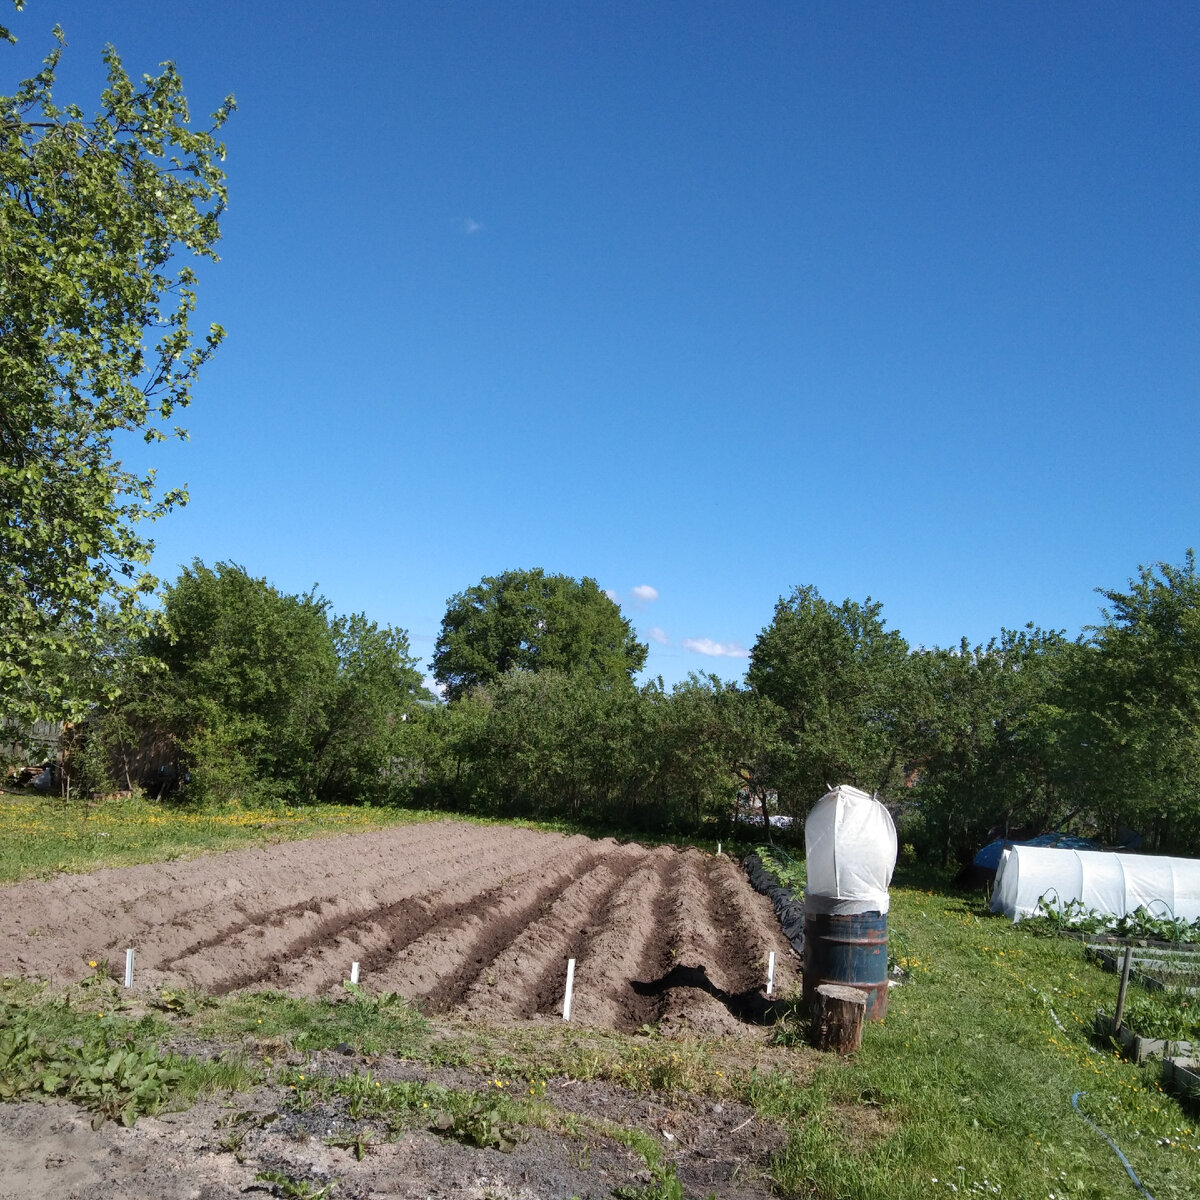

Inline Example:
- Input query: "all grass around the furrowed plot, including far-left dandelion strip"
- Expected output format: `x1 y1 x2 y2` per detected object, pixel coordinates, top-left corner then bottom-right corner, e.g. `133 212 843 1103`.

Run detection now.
0 800 1200 1200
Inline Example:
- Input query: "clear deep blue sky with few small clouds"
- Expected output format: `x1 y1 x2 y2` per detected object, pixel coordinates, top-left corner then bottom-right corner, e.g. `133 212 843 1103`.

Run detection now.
11 0 1200 683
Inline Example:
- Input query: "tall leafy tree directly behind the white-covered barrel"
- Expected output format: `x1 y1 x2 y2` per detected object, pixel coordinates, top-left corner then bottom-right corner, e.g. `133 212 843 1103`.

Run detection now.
746 587 908 816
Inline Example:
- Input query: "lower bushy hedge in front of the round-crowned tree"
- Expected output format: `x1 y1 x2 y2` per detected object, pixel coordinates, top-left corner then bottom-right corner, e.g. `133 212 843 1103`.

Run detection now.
408 670 769 832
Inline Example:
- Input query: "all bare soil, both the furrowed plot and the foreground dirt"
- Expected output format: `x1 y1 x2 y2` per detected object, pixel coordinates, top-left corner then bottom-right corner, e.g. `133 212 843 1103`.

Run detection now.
0 821 800 1200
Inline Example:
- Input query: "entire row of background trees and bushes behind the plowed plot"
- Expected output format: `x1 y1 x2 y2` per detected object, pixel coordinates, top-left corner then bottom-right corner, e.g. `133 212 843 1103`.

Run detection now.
51 554 1200 860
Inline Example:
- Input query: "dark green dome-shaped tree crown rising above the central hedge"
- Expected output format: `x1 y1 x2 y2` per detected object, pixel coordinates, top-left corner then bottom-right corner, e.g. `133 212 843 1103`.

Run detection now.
433 569 648 700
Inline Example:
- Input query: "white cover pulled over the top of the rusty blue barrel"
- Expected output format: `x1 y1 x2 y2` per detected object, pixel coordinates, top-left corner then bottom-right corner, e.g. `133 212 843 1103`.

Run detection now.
804 784 896 916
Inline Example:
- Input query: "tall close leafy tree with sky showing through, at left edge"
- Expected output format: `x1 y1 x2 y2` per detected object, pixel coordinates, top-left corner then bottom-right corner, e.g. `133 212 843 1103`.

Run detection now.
0 18 233 722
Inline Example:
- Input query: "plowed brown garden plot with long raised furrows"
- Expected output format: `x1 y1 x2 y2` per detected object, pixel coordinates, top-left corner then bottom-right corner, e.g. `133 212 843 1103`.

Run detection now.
0 821 799 1033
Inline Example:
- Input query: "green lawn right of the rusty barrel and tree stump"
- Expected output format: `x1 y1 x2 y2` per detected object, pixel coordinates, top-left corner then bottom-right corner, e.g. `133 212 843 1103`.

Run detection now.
756 888 1200 1200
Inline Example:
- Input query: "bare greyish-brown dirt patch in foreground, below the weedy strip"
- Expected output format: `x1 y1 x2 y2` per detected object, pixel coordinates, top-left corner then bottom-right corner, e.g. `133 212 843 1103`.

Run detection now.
0 1067 782 1200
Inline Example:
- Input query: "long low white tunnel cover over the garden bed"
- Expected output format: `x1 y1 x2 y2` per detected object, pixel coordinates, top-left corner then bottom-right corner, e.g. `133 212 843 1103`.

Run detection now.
991 846 1200 920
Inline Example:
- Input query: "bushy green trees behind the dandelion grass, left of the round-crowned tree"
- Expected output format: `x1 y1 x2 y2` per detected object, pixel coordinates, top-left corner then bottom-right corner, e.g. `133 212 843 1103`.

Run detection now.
140 560 424 802
